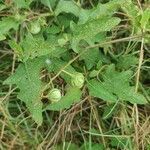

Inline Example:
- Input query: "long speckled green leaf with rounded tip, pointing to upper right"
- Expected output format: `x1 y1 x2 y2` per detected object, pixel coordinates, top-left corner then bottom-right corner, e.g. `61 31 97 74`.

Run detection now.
71 17 120 52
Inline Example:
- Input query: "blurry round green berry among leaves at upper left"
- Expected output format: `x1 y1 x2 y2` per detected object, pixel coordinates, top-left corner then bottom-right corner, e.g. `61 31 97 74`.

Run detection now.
30 21 41 34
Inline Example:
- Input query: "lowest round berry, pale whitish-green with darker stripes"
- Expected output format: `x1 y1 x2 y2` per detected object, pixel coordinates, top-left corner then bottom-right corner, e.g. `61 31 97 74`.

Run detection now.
48 88 61 102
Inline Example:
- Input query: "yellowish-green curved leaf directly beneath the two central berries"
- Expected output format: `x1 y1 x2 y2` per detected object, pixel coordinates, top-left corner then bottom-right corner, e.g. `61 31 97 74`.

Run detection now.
46 87 82 111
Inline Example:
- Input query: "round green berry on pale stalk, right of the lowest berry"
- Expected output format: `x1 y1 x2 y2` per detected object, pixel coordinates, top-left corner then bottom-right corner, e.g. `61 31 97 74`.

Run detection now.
71 73 84 88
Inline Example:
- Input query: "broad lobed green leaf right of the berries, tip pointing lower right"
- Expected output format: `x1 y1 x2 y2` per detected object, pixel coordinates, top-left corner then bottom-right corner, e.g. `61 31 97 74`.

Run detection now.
88 65 147 104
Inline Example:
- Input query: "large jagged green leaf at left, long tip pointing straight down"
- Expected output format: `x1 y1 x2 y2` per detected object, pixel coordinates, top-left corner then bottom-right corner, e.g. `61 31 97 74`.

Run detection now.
4 58 45 125
